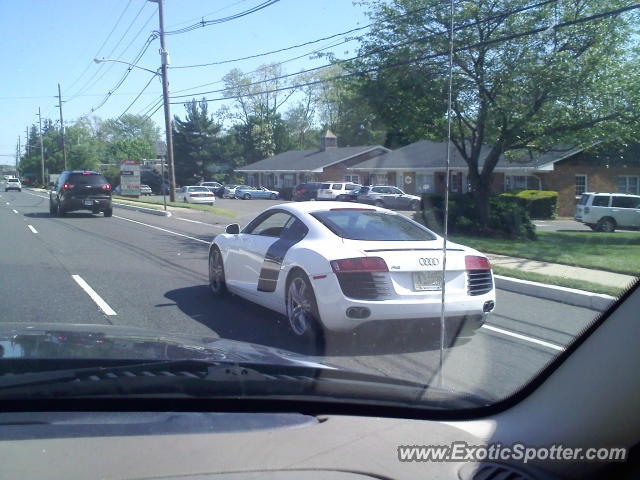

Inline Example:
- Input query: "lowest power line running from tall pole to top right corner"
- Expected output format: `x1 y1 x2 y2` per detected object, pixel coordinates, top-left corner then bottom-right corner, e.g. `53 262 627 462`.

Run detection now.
171 4 640 105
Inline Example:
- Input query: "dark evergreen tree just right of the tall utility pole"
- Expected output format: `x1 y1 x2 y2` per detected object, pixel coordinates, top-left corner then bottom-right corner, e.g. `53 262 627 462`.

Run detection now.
173 99 224 185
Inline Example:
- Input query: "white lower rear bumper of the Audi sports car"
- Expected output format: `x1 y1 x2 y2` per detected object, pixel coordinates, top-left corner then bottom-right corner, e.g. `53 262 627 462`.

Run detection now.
312 275 496 331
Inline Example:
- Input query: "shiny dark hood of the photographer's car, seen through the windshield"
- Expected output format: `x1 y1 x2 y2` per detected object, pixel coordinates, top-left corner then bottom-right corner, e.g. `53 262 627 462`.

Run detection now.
0 323 334 369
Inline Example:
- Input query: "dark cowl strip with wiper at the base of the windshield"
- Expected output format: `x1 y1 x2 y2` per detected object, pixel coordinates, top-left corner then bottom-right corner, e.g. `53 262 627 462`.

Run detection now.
0 360 488 409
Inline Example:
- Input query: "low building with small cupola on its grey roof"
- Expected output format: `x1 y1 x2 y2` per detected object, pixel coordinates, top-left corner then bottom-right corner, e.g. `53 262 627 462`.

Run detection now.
235 130 391 188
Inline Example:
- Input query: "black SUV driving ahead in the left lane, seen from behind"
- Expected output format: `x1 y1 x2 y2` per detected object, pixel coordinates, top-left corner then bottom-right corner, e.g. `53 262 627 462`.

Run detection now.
49 170 113 217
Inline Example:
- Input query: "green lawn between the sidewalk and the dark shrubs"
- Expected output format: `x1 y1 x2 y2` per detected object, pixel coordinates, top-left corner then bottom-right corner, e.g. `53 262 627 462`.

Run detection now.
451 231 640 275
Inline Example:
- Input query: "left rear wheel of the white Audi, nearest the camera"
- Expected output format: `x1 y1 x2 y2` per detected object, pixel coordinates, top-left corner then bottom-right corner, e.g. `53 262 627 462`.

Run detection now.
285 271 325 354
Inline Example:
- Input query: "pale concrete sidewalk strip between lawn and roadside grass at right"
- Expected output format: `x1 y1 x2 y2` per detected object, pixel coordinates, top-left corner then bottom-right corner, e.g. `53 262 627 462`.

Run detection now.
487 253 636 288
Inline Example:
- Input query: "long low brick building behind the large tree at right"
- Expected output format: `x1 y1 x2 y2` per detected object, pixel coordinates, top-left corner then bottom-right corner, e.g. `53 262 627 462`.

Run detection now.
347 140 640 216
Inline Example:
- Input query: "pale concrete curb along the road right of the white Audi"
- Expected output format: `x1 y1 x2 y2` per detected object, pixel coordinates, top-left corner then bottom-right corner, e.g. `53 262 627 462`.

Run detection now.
493 275 616 312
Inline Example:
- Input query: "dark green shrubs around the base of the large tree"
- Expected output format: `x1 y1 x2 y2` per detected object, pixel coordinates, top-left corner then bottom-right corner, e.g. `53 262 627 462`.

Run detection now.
414 193 536 239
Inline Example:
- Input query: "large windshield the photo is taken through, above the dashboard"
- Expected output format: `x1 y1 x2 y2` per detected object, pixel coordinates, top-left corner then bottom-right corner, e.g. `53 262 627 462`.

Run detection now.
0 0 640 416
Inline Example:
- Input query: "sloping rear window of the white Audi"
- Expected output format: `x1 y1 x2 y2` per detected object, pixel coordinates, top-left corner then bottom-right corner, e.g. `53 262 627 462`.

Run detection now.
311 210 436 241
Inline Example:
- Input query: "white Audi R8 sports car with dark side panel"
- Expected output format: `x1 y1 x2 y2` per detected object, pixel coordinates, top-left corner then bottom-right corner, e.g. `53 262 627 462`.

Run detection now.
209 202 495 348
